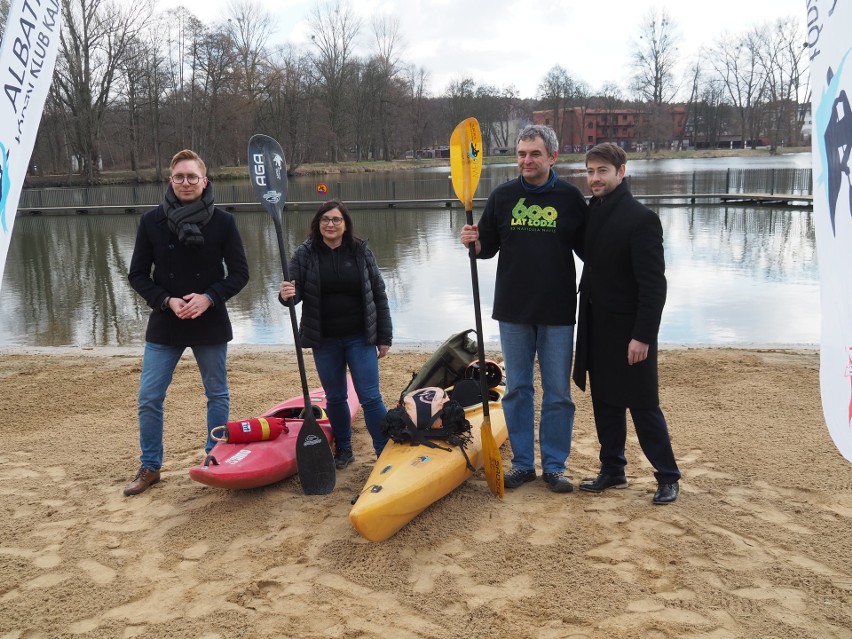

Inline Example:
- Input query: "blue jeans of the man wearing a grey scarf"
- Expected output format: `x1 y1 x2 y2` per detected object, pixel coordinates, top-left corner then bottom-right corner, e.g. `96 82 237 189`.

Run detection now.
139 342 231 470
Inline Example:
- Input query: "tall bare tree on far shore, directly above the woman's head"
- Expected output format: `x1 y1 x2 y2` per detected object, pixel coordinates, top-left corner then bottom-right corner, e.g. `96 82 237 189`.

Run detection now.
308 0 361 162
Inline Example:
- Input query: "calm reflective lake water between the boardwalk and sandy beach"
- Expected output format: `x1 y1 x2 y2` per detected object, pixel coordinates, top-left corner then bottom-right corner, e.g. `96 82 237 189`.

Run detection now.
0 206 819 346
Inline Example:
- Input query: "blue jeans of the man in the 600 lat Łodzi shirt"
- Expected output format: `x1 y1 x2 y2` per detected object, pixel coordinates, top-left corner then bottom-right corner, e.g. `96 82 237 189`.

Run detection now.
500 322 574 473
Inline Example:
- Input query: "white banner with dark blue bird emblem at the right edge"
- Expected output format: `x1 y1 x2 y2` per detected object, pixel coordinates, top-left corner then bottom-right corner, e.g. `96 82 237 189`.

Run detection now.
806 0 852 461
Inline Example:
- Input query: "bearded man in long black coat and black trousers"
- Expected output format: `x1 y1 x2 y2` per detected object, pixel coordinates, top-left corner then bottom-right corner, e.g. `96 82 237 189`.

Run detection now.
574 143 680 504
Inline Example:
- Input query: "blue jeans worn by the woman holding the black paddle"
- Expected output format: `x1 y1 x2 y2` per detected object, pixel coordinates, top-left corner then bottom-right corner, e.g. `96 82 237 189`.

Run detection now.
312 335 388 457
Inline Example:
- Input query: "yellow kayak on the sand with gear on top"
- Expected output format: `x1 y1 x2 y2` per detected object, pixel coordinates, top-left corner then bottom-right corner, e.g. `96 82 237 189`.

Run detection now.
349 385 509 541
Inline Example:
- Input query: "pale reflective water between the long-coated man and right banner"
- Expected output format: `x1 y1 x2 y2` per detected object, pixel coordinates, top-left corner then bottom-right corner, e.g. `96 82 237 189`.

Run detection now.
660 207 819 345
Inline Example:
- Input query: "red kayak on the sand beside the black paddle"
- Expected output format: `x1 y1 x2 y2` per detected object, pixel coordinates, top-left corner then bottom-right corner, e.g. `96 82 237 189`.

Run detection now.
189 375 359 489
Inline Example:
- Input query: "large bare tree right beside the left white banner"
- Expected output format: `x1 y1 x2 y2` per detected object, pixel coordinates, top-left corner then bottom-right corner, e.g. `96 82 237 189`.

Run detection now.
52 0 151 182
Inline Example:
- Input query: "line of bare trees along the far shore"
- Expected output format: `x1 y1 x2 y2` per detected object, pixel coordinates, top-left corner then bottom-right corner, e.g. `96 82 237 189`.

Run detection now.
0 0 807 183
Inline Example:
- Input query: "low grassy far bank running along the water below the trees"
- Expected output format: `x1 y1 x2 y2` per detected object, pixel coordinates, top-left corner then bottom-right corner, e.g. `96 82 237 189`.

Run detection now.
24 147 811 188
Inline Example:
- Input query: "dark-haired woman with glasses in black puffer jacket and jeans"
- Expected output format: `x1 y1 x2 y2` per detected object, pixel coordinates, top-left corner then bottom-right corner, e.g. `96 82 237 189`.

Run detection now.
278 201 393 469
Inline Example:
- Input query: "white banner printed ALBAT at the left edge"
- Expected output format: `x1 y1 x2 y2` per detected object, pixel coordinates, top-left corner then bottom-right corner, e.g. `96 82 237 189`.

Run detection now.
0 0 62 294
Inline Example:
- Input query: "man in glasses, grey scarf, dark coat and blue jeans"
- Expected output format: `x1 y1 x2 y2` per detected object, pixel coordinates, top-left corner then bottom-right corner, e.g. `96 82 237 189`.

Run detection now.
124 149 249 495
